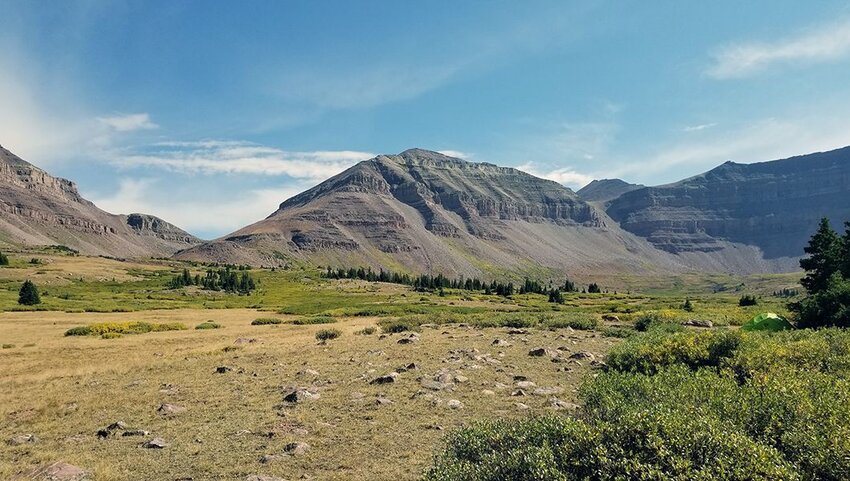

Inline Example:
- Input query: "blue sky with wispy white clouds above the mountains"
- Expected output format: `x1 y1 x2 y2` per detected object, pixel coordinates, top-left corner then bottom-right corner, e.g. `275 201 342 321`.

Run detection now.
0 0 850 238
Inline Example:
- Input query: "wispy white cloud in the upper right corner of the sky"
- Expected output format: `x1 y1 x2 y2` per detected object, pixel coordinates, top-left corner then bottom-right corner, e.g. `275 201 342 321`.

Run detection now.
706 20 850 79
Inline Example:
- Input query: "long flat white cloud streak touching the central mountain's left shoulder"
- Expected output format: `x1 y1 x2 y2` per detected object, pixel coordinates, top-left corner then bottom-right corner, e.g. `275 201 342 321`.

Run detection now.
113 140 375 180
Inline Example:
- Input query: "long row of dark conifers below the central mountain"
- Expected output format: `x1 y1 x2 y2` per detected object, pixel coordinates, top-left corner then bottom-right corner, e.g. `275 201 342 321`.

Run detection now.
322 267 588 303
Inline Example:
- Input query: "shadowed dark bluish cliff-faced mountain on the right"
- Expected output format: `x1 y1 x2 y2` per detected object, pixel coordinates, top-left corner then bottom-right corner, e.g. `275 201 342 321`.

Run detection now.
607 147 850 272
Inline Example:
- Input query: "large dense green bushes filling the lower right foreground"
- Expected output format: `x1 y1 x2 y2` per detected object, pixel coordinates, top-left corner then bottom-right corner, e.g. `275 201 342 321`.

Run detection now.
424 329 850 481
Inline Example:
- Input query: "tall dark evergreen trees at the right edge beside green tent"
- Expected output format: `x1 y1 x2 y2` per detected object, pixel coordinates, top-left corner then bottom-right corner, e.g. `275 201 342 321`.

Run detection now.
789 218 850 327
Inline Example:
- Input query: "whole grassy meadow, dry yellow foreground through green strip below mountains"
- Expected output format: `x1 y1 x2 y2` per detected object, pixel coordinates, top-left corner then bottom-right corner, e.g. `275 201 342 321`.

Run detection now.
0 252 793 480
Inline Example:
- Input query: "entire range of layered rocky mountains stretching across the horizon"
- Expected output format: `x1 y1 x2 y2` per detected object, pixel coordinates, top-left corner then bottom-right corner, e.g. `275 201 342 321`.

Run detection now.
0 142 850 277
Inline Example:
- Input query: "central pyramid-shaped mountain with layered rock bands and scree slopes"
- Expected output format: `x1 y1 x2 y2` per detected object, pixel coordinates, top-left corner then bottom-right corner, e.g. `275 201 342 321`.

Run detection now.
177 149 681 276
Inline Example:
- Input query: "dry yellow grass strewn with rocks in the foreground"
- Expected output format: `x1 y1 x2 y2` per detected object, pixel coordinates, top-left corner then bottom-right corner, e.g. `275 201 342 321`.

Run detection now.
0 309 614 481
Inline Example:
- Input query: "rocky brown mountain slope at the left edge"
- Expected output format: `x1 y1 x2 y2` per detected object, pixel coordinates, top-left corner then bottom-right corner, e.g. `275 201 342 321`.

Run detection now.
0 146 200 257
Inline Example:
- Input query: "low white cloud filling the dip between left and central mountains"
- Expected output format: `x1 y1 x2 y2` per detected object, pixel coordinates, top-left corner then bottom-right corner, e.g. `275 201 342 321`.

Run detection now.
88 178 305 235
